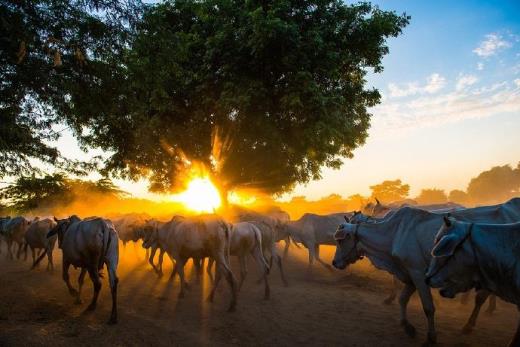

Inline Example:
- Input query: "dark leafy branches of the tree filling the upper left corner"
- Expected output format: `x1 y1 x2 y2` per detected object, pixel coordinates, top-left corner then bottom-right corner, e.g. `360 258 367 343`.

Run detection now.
0 0 141 177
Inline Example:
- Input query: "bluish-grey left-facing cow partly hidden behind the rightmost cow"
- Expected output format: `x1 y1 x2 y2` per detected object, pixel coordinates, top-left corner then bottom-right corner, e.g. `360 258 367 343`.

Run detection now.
333 199 520 343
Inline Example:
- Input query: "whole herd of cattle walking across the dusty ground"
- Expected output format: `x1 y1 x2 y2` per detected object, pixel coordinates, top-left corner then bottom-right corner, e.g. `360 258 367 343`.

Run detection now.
0 198 520 346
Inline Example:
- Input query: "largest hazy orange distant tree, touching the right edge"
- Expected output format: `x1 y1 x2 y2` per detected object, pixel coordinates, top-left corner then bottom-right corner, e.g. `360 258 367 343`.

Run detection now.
467 163 520 203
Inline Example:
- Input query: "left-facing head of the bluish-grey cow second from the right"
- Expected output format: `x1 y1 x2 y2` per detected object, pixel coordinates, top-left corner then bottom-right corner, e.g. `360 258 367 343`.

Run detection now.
332 223 362 269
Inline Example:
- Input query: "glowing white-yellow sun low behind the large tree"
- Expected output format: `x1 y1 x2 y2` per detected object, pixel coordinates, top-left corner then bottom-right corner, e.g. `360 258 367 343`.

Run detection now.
172 177 221 213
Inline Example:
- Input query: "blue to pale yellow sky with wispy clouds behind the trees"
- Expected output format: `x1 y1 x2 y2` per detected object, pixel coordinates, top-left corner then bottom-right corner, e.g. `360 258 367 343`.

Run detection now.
50 0 520 199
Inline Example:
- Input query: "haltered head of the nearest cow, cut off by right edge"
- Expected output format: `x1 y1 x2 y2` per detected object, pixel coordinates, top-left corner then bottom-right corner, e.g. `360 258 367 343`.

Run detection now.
426 216 478 298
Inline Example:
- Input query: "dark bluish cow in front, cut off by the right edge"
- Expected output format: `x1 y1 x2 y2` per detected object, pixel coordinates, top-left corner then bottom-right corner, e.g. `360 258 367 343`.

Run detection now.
426 217 520 346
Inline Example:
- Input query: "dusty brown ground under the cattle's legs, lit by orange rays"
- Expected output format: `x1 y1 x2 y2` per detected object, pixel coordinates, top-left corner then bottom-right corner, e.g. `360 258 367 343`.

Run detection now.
0 245 518 346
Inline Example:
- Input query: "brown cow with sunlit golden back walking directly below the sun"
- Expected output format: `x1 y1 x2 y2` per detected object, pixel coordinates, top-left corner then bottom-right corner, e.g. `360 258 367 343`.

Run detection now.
155 215 237 312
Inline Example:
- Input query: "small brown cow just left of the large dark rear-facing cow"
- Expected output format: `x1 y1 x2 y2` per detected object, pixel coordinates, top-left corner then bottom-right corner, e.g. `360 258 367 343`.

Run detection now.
25 218 57 270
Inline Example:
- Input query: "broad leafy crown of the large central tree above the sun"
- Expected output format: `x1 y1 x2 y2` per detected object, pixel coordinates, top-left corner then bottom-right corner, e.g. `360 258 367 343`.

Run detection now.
55 0 409 197
